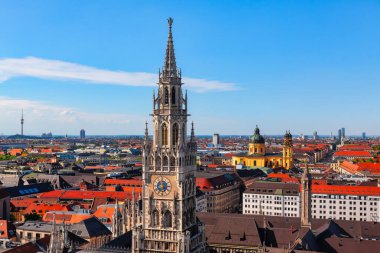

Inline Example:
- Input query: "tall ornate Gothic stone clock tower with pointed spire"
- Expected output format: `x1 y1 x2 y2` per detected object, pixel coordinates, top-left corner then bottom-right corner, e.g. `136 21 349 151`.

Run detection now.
132 18 205 253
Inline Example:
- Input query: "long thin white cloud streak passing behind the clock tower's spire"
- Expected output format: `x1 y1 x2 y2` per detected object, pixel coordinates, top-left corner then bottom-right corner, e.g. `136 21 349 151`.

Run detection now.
0 57 237 92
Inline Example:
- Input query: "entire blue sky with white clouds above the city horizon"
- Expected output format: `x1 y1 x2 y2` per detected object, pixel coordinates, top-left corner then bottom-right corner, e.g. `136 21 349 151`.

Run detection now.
0 0 380 135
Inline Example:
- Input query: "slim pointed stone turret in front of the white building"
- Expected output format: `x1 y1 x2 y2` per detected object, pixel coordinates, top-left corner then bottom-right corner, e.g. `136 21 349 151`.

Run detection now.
301 164 311 228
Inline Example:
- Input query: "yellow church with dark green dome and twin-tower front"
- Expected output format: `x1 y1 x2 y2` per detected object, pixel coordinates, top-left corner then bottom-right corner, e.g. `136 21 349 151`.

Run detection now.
232 126 293 169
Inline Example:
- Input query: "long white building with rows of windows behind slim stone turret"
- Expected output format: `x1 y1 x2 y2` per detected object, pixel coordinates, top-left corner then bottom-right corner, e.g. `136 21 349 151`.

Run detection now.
243 182 380 222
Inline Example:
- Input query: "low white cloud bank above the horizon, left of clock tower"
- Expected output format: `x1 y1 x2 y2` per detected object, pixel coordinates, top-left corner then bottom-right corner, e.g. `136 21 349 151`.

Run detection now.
0 97 148 135
